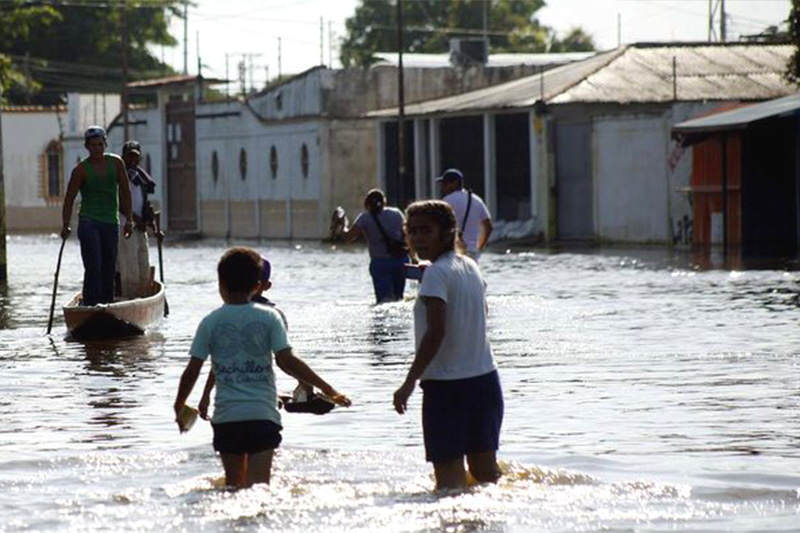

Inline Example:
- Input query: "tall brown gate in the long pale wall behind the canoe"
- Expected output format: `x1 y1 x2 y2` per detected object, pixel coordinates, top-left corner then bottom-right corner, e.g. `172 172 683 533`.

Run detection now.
165 100 198 231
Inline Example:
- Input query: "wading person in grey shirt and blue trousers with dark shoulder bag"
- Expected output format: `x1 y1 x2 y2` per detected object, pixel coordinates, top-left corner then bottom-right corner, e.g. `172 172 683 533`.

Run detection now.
342 189 408 303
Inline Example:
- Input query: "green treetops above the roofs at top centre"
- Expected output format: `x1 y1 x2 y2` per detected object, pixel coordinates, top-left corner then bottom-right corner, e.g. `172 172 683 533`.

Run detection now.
340 0 594 67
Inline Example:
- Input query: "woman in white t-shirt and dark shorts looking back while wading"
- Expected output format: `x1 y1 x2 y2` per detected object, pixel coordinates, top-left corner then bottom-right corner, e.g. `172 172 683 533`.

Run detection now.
394 200 503 489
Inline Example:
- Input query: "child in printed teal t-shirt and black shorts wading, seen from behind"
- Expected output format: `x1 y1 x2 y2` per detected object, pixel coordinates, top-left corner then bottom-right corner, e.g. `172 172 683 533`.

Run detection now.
174 247 350 488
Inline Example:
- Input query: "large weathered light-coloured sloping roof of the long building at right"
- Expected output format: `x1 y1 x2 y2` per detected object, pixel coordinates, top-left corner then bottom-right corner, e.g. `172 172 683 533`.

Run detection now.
370 43 794 117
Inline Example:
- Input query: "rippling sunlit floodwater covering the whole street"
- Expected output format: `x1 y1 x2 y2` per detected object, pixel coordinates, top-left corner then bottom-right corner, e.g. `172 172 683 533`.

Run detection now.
0 236 800 532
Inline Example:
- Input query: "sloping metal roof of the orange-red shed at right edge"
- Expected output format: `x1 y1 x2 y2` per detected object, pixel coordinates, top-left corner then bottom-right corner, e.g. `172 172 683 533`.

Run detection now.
672 93 800 136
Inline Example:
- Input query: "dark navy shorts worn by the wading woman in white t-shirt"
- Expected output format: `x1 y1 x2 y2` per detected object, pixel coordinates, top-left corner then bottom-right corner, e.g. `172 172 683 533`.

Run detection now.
420 370 503 463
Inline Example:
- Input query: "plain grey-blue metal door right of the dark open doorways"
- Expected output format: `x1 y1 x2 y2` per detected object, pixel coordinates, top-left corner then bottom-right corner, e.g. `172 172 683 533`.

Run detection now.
556 122 594 239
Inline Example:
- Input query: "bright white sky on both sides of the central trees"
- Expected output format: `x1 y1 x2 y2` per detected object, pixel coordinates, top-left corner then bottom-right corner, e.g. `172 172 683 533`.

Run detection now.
158 0 791 92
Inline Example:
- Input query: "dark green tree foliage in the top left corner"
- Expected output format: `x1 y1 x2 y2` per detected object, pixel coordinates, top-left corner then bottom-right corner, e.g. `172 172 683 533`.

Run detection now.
0 0 183 103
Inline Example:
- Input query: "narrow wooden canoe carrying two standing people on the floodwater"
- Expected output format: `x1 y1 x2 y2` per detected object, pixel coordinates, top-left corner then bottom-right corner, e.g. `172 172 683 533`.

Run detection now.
64 280 166 340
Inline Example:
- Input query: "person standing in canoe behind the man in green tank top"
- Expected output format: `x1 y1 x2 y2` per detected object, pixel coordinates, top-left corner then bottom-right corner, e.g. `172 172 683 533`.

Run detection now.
117 141 162 298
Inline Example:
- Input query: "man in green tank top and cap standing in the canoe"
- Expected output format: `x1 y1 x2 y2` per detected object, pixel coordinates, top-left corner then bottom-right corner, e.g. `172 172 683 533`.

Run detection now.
61 126 133 306
